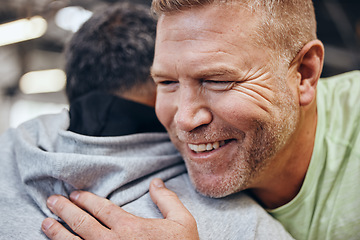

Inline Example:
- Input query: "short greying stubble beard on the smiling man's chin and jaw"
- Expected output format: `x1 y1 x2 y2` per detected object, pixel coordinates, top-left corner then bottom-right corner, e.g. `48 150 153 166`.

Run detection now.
185 123 284 198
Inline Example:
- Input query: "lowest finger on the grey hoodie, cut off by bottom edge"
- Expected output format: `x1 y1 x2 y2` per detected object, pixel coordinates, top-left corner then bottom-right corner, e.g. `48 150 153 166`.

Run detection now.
41 218 81 240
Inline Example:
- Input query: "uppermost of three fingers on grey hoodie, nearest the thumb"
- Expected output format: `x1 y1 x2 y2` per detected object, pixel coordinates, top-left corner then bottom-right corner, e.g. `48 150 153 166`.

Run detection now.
70 191 133 228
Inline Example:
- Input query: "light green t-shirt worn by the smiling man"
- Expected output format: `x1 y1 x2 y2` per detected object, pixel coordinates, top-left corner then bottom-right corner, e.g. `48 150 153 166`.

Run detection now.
269 71 360 240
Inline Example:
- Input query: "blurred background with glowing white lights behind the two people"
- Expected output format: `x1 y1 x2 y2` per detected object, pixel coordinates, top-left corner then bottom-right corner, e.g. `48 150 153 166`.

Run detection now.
0 0 360 134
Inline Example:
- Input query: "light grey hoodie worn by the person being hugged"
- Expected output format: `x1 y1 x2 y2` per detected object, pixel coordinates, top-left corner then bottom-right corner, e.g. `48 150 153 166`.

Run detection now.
0 110 291 240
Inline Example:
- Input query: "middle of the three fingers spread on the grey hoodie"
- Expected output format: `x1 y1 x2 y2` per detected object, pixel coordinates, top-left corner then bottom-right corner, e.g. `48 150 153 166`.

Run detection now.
46 195 110 240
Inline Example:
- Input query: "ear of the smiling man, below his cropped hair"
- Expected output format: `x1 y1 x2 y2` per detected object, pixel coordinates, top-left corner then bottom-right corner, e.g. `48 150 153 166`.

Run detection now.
293 40 324 106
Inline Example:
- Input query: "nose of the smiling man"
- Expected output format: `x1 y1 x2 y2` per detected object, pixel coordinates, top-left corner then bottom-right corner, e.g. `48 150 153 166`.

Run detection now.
174 87 213 132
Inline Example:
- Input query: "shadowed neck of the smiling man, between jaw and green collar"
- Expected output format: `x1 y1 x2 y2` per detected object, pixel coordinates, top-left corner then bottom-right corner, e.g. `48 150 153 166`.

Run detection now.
249 102 317 209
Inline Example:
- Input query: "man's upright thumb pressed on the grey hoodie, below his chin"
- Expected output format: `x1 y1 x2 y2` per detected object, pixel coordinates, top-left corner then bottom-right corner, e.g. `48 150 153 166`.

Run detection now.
149 178 196 225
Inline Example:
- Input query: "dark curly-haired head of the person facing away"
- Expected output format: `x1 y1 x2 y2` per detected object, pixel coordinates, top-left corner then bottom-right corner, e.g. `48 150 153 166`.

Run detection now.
65 3 156 103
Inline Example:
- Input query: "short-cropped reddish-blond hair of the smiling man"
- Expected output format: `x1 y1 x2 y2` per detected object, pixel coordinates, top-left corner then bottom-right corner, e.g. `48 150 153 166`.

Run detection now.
152 0 317 63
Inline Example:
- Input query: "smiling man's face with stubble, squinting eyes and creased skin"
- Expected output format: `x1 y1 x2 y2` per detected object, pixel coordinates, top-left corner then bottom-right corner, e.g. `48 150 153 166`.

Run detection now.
152 5 299 197
